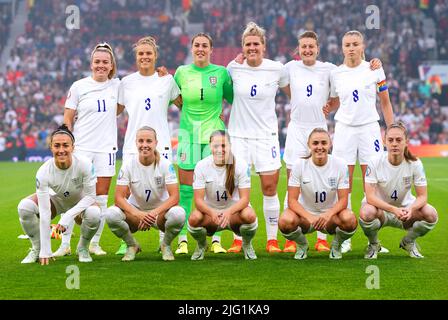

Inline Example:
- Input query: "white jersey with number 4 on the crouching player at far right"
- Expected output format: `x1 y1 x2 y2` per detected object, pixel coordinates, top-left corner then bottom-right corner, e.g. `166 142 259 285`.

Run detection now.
363 152 427 207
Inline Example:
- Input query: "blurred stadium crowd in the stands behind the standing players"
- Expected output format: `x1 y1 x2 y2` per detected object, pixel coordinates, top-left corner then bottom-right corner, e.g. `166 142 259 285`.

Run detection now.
0 0 448 158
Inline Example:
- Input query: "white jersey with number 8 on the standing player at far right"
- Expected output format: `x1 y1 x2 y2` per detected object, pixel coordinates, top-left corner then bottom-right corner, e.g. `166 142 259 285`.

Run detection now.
330 61 386 126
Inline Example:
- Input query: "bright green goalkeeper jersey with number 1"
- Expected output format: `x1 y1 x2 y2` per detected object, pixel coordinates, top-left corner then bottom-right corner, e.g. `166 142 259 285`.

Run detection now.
174 64 233 144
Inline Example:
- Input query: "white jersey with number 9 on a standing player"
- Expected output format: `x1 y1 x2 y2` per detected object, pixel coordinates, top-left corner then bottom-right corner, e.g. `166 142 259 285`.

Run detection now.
285 60 336 128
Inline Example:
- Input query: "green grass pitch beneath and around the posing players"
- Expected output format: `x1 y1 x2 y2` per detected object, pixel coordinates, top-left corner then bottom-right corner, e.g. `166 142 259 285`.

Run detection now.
0 158 448 300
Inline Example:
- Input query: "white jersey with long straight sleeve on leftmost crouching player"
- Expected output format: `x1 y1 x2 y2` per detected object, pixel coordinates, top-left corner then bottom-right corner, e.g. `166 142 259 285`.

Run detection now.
36 154 96 257
